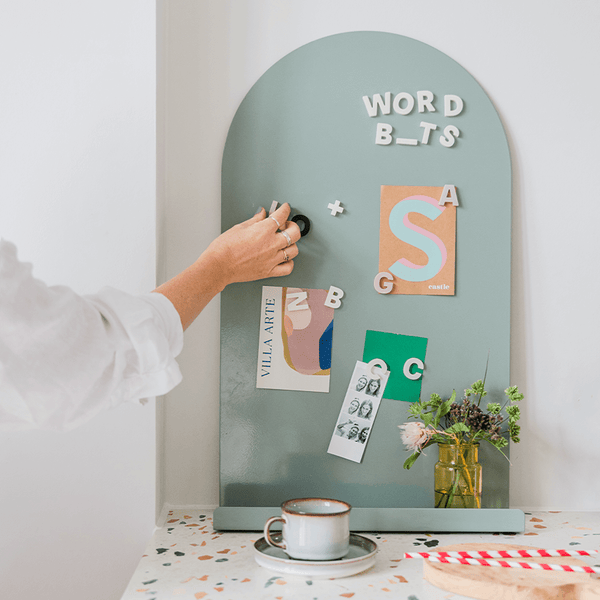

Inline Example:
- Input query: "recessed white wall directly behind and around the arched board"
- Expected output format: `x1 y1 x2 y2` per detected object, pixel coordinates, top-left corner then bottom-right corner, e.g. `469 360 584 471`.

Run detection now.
159 0 600 509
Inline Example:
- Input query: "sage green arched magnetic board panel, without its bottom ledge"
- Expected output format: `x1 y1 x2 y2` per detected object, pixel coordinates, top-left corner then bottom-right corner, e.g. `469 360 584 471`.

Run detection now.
220 32 511 524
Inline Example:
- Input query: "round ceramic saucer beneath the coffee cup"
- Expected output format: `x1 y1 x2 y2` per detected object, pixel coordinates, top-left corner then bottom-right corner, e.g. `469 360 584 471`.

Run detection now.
254 533 377 579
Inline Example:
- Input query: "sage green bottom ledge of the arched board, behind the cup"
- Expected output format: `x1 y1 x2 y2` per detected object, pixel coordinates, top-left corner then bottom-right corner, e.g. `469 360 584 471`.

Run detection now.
213 506 525 533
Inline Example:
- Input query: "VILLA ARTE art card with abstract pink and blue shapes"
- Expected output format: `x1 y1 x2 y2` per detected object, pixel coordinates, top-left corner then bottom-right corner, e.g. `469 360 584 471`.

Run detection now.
256 286 334 392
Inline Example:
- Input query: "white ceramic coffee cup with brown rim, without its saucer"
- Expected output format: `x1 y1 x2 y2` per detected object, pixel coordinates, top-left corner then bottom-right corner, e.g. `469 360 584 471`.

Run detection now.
264 498 352 560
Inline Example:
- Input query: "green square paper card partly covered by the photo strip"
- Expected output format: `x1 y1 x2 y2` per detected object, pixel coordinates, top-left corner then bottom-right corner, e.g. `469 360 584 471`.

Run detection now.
363 330 427 402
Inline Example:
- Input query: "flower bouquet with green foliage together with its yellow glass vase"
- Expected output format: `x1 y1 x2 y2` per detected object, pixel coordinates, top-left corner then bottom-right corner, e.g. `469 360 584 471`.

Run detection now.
399 379 523 508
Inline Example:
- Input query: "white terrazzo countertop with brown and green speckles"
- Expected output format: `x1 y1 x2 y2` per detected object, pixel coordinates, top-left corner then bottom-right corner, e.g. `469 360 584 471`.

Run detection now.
122 508 600 600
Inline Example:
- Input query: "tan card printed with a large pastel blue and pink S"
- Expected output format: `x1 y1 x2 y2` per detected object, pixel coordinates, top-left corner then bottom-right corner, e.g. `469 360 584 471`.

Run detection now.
379 185 456 296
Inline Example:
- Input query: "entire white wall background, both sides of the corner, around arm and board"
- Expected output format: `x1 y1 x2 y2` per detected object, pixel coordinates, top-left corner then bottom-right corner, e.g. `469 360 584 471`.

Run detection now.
0 0 600 600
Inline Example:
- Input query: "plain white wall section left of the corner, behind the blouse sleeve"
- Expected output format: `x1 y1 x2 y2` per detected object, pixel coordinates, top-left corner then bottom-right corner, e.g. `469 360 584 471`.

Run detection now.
0 0 156 600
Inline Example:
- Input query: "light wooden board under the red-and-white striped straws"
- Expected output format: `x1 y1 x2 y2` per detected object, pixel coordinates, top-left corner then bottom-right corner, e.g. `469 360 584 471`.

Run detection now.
423 544 600 600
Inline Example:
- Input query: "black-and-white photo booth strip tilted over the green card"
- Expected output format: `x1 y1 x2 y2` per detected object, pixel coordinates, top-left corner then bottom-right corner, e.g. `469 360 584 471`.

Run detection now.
327 361 390 462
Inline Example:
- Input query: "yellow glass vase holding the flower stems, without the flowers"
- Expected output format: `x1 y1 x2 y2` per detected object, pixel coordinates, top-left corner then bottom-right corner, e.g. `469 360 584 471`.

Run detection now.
434 444 482 508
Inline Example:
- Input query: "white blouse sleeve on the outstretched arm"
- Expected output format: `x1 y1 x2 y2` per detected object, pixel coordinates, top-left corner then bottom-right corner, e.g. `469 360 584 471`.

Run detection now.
0 240 183 430
